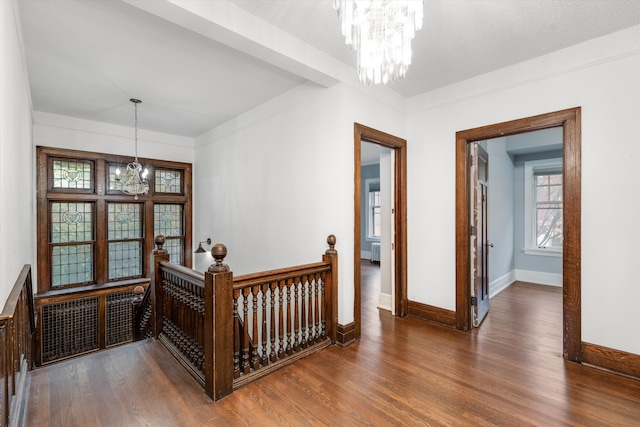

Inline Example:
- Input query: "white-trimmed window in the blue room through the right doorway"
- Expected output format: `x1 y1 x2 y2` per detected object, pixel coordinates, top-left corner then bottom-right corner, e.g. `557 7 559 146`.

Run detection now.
524 159 563 255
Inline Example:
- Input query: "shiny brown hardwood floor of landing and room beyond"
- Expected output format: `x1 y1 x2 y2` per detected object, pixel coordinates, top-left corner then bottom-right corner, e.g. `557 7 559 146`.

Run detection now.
26 264 640 426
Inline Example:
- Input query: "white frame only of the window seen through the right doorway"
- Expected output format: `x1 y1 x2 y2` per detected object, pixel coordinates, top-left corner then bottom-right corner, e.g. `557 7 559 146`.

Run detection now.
524 158 564 257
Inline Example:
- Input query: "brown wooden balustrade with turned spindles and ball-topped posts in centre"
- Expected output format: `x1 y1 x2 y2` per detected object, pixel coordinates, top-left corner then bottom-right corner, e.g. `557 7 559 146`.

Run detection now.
133 235 338 400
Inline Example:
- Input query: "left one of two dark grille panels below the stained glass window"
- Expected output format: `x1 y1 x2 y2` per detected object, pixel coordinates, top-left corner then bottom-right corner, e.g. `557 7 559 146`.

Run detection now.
42 297 98 363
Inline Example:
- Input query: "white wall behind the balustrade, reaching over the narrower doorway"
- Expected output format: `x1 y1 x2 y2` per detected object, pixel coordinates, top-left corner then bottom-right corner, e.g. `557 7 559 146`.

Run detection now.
194 85 404 324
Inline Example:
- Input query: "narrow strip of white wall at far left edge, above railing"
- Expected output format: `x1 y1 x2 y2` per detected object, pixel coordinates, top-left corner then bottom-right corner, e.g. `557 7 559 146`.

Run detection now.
0 1 35 310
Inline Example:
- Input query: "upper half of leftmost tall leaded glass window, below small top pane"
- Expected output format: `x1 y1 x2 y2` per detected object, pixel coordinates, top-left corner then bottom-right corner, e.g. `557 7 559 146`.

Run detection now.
50 202 93 243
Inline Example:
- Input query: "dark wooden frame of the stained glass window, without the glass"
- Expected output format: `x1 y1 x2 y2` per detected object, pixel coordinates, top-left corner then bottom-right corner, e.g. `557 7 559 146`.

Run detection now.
36 146 193 293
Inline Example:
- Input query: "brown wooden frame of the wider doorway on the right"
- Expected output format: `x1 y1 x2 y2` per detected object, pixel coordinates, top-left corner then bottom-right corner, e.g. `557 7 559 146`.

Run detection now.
456 107 582 362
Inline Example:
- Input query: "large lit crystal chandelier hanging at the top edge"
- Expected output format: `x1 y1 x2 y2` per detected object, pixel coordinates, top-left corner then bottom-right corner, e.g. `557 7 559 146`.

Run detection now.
333 0 423 86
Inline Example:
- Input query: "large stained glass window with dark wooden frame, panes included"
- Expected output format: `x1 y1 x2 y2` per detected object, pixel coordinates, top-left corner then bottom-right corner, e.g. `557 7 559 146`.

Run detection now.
36 147 192 293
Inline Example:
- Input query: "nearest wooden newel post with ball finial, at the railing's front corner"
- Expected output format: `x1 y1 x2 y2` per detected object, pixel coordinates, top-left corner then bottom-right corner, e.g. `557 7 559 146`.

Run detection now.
204 243 233 400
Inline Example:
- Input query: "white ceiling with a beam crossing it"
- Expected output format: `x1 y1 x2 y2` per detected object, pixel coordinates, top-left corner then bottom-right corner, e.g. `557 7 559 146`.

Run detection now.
18 0 640 137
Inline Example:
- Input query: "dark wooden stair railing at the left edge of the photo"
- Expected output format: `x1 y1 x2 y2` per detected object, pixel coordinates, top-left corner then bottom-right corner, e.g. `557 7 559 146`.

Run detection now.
0 264 36 426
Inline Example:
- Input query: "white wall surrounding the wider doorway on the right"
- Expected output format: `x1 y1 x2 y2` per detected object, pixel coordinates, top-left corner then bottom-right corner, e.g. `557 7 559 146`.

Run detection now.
407 26 640 354
